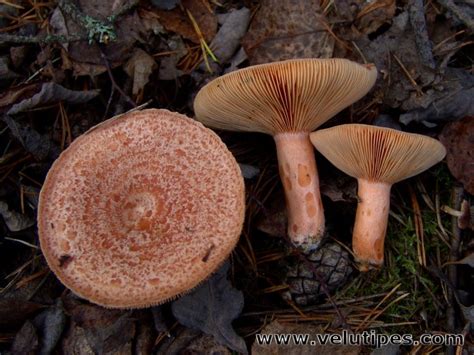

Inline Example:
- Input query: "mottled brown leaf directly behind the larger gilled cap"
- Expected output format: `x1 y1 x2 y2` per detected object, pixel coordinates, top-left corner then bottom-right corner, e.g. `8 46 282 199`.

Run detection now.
242 0 334 65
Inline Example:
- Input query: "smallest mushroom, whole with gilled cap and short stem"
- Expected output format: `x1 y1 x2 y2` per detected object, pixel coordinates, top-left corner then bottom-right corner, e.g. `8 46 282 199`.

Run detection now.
310 124 446 271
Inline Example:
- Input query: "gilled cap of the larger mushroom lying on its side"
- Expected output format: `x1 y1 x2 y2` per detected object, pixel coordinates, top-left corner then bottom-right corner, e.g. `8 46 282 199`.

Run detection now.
194 59 377 134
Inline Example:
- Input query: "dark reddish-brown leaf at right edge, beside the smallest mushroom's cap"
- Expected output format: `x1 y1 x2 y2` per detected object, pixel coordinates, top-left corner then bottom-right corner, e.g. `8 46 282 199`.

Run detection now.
440 116 474 194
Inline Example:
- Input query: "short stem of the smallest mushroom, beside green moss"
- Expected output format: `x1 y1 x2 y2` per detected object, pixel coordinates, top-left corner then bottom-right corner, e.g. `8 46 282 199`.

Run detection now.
352 179 392 271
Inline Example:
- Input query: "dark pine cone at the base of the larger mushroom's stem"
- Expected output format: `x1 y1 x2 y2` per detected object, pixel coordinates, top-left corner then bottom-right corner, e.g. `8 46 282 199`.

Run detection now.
283 243 353 306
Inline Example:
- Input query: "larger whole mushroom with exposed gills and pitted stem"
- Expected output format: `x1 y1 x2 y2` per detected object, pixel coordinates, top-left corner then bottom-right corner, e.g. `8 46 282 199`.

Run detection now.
194 59 377 250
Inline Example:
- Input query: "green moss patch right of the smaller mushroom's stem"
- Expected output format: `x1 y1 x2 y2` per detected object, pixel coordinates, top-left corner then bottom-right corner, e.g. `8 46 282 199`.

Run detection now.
336 171 452 334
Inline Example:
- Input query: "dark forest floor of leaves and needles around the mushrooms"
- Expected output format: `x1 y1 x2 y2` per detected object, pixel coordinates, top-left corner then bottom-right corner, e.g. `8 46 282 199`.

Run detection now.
0 0 474 354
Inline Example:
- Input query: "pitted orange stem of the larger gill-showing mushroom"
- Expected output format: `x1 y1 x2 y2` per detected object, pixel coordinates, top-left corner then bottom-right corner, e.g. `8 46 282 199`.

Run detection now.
274 132 324 251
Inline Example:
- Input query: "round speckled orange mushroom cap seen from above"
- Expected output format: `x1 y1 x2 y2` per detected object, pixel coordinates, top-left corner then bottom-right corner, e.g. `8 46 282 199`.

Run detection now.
38 110 245 308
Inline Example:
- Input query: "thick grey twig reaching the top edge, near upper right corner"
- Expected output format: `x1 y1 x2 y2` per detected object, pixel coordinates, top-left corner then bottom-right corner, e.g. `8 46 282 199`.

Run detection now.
409 0 436 69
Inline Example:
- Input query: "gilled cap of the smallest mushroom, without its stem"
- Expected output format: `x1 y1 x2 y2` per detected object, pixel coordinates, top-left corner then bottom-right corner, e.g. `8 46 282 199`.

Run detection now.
310 124 446 184
